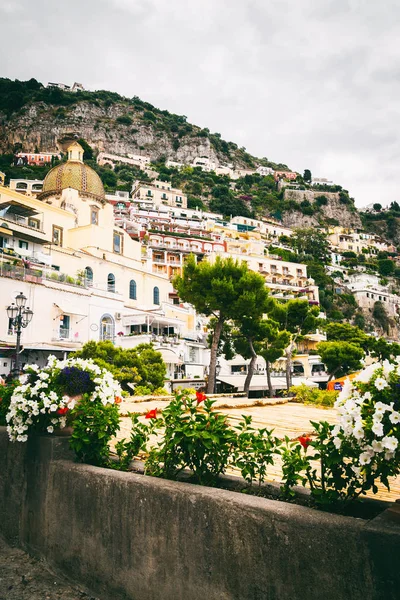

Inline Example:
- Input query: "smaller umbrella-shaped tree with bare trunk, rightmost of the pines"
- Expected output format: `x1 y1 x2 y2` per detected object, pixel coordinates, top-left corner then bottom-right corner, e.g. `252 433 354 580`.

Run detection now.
269 300 319 390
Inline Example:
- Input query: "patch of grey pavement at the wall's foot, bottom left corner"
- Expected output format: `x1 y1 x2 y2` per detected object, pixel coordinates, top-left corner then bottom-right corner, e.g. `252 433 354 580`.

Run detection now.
0 537 99 600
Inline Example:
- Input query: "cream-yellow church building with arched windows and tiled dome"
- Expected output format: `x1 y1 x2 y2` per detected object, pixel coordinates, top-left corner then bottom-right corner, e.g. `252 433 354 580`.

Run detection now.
0 143 200 374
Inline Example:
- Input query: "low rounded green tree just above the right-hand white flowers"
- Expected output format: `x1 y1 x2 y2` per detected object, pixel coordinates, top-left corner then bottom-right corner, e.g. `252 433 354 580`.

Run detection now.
317 341 364 380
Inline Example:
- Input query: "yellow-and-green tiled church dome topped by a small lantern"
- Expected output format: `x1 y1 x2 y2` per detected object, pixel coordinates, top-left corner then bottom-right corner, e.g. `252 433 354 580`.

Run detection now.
38 142 105 203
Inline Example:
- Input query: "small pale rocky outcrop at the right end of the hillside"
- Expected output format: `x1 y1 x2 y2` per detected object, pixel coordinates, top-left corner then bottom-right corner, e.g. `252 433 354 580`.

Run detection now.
282 189 362 228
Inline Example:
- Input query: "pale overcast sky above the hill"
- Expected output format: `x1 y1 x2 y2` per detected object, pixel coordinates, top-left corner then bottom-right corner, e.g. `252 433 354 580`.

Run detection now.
0 0 400 206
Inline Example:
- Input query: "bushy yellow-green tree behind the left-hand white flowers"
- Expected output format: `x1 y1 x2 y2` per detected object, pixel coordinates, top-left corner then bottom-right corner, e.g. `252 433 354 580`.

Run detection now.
74 341 166 392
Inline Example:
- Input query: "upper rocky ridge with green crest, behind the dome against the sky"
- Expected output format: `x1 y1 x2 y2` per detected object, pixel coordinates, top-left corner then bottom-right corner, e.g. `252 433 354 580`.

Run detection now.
0 78 287 169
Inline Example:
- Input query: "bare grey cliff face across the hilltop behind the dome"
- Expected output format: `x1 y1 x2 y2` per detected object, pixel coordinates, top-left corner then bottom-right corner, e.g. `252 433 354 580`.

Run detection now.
0 101 231 166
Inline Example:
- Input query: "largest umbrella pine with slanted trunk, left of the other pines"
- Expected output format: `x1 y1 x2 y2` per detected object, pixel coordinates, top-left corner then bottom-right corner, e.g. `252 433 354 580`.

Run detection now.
173 255 265 394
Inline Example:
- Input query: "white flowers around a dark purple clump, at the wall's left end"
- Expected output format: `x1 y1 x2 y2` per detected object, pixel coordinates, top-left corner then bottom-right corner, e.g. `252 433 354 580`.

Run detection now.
6 356 121 442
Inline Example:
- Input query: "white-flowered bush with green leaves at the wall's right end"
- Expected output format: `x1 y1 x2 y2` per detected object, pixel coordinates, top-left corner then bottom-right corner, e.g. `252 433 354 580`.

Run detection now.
282 357 400 505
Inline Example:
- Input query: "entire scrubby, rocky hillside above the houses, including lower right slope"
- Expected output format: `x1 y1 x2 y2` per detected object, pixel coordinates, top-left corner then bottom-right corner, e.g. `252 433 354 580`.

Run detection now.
0 78 368 227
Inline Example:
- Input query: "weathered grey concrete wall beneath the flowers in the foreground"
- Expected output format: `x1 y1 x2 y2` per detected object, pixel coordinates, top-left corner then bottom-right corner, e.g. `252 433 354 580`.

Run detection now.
0 428 400 600
